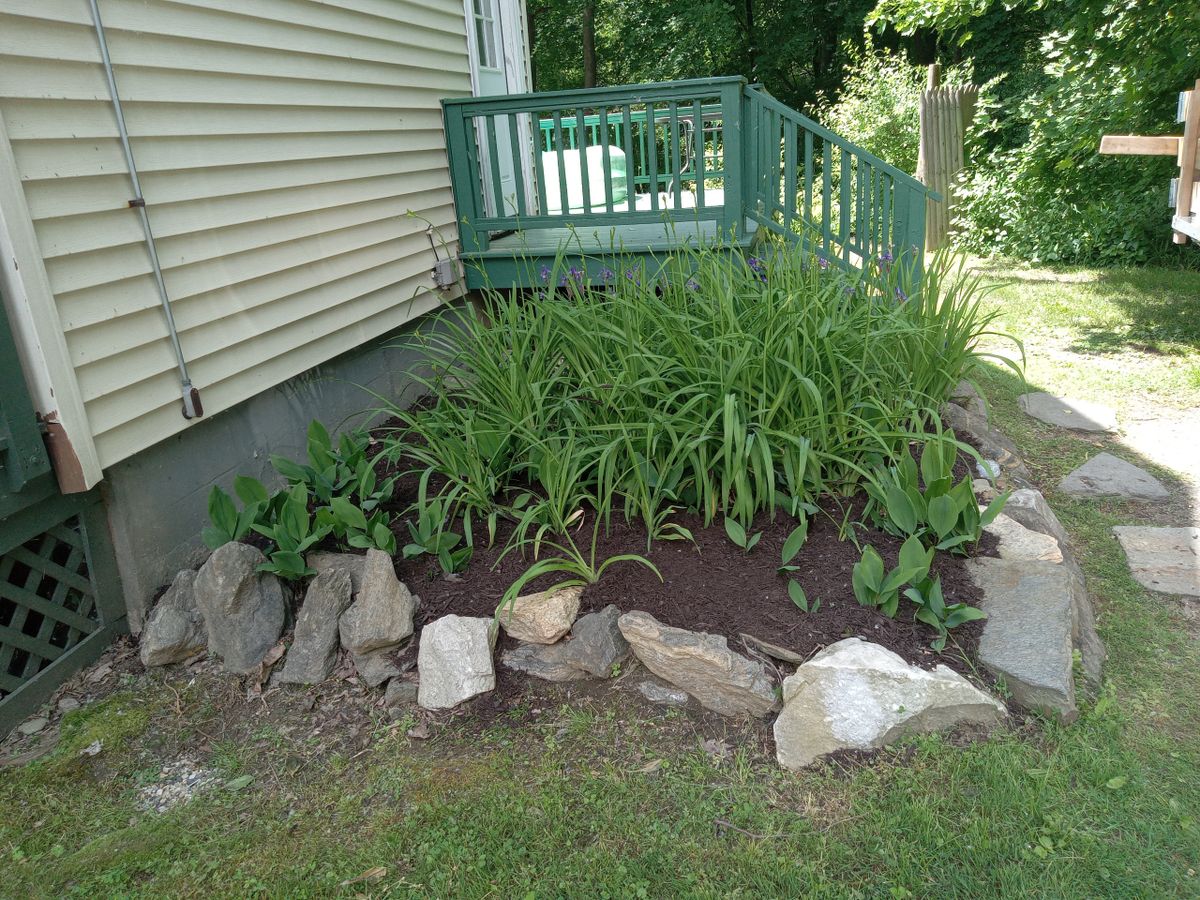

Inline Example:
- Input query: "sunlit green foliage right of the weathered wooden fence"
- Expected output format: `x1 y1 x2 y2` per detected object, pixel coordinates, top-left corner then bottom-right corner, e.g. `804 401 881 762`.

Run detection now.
869 0 1200 264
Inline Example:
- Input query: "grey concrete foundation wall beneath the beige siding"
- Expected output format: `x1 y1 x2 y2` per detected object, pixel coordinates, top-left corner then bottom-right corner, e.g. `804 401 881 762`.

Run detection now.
102 307 453 632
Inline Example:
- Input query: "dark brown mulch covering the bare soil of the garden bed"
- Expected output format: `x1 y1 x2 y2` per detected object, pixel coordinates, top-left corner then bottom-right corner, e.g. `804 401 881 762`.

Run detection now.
396 494 989 673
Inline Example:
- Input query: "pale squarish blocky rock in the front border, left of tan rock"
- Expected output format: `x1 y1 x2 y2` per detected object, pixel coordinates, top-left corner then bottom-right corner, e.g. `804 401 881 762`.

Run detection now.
416 616 496 709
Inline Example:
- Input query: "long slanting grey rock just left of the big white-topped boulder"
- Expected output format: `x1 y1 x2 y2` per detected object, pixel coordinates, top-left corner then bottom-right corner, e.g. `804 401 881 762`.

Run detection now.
618 611 775 716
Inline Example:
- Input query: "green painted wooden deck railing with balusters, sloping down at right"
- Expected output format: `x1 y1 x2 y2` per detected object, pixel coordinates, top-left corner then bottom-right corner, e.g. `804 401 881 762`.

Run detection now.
443 77 938 266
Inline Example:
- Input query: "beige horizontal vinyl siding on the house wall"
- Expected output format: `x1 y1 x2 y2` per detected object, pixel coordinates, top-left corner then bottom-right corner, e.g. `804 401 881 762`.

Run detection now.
0 0 470 466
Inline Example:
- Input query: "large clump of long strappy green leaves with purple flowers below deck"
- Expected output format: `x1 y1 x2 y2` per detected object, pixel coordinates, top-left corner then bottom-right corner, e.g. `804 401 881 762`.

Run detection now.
385 243 1003 541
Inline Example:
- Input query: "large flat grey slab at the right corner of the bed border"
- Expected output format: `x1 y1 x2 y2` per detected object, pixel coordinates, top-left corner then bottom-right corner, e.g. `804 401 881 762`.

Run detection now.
966 558 1104 721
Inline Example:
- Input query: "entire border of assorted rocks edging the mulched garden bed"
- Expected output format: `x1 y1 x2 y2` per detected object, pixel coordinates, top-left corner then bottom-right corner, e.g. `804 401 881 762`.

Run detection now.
131 383 1105 768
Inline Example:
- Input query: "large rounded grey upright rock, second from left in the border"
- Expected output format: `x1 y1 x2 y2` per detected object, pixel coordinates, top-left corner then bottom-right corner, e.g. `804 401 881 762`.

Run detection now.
194 542 287 674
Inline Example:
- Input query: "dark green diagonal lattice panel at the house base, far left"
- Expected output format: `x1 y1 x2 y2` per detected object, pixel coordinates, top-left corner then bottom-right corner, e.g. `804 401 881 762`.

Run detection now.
0 516 102 698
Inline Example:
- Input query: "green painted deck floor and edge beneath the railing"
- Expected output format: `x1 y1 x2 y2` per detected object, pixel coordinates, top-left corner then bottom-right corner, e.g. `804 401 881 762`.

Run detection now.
463 218 758 289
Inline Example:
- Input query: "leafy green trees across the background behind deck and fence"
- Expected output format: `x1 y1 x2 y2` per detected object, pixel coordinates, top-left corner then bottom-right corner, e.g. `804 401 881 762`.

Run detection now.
528 0 1200 265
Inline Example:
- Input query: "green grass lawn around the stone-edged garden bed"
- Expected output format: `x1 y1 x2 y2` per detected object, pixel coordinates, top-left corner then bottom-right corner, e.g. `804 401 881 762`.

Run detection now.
0 269 1200 898
